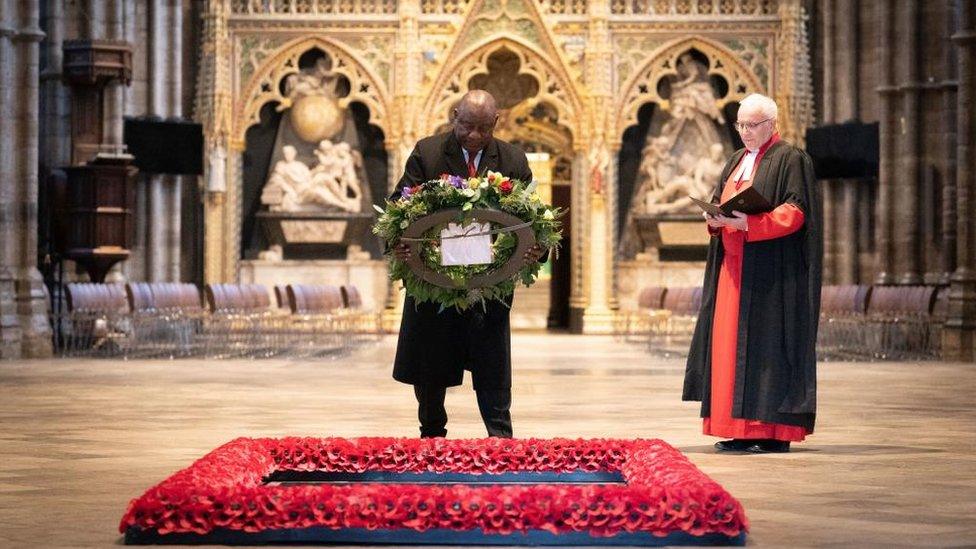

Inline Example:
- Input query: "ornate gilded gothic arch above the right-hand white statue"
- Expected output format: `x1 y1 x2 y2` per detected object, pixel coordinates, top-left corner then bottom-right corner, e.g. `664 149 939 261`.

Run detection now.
615 36 772 138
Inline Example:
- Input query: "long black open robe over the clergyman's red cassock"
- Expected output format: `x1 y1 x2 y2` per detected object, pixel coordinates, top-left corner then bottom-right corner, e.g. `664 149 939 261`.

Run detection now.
683 141 823 432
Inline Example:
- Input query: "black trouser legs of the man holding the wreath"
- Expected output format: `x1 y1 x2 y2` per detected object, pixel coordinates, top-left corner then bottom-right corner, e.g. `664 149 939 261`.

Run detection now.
413 385 512 438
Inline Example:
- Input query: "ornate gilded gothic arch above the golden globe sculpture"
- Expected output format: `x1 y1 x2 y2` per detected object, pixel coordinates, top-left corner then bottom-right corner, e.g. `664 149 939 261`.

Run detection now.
233 36 390 143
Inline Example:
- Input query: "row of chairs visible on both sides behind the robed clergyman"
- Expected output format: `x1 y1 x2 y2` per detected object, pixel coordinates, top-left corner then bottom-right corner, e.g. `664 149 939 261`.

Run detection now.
615 285 948 360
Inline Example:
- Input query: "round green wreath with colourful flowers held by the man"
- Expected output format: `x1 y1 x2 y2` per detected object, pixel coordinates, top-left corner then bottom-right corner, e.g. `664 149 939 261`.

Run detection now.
373 171 562 310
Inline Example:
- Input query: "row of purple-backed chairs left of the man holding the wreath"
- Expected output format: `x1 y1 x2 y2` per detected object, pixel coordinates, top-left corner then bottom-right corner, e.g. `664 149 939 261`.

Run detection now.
54 282 381 358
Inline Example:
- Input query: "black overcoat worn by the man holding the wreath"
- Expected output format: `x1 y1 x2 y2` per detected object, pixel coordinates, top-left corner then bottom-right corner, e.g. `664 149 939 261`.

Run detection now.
392 132 532 390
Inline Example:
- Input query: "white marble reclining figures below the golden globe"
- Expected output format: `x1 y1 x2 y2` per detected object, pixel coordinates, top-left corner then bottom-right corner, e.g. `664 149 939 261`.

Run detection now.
261 139 362 212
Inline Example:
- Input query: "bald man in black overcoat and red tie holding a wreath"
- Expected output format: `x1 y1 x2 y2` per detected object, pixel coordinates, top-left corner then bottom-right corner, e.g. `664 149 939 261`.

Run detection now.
391 90 542 437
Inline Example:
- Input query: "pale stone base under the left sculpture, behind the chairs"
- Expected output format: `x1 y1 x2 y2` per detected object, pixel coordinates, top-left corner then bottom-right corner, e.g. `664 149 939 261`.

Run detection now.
240 259 390 311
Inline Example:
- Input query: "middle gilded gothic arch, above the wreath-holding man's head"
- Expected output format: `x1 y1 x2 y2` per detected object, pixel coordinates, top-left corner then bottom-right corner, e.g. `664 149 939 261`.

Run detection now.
418 37 583 141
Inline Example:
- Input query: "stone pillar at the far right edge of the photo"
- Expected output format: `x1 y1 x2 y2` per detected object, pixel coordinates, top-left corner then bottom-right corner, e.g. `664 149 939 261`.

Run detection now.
943 2 976 361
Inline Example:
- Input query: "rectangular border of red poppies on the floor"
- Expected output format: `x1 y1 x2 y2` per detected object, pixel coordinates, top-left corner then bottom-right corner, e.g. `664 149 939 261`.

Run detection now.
119 438 748 542
